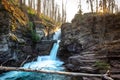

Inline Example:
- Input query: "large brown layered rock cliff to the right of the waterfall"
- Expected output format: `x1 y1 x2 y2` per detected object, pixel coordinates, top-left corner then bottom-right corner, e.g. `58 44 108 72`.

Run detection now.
58 13 120 79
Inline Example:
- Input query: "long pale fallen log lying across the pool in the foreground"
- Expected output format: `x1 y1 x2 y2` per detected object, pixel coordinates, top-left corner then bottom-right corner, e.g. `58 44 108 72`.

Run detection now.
0 66 103 78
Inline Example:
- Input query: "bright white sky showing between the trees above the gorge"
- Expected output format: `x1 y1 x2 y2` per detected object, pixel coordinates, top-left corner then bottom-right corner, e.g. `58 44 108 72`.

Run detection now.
55 0 120 22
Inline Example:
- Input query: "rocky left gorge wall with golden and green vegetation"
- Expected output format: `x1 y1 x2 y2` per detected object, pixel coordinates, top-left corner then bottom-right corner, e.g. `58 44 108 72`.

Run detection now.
0 0 56 70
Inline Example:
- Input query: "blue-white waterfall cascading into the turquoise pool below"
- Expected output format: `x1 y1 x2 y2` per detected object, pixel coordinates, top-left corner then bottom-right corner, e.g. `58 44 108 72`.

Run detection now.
0 30 69 80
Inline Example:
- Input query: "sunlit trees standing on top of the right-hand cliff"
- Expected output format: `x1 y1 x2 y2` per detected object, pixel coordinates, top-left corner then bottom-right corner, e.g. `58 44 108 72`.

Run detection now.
86 0 118 13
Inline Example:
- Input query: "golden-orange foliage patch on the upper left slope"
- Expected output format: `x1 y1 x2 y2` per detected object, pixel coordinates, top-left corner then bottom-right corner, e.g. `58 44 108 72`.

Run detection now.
2 0 27 27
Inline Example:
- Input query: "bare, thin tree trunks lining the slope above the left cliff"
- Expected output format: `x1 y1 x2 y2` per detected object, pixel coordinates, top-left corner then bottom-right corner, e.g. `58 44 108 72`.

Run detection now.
18 0 67 22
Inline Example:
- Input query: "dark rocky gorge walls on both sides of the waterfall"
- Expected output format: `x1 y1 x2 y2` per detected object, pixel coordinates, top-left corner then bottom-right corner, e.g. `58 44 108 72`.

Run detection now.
0 0 120 80
